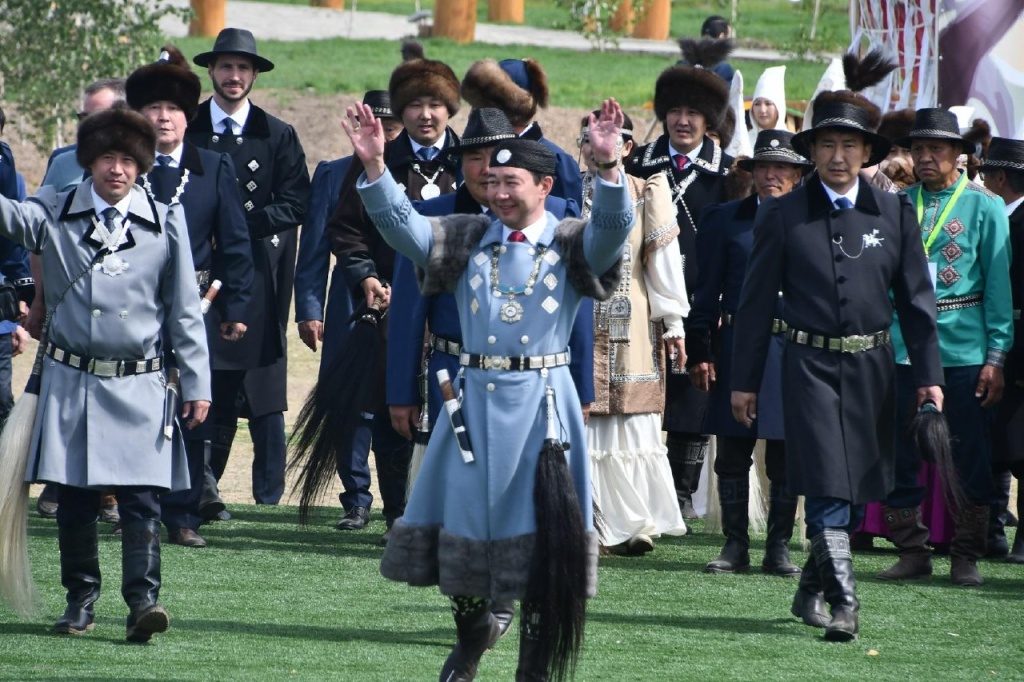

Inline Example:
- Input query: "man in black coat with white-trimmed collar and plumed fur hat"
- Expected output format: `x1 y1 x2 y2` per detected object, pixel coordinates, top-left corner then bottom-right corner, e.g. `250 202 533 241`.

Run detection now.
626 38 732 519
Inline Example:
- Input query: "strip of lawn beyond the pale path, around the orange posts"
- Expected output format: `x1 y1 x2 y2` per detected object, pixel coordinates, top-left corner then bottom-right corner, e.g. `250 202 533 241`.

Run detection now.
245 0 850 51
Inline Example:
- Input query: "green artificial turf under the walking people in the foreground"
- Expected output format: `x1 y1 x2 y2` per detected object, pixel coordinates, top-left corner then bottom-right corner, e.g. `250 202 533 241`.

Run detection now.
0 506 1024 682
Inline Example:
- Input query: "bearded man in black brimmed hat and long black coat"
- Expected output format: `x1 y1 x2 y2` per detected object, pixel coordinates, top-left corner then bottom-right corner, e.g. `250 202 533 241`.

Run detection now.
186 29 309 518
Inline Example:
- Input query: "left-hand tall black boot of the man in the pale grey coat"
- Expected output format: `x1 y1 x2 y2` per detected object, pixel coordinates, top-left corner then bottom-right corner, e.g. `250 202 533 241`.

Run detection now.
53 521 99 635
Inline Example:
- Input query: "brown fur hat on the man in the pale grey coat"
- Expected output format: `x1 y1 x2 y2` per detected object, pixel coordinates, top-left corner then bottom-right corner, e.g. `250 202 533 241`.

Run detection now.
75 104 157 173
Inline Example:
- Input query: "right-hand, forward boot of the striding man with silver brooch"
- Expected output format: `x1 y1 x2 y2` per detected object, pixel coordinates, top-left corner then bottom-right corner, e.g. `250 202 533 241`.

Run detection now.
811 528 860 642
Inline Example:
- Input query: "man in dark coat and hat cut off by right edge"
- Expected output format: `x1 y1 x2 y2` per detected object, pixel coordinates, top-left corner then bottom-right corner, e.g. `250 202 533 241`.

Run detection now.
981 137 1024 563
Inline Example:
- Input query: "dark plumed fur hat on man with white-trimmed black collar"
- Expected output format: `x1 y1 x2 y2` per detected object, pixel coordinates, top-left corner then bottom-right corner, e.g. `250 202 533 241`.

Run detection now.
654 38 733 124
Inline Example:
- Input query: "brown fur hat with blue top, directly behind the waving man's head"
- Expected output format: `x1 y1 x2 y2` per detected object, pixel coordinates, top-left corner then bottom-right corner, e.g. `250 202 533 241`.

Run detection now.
462 57 548 127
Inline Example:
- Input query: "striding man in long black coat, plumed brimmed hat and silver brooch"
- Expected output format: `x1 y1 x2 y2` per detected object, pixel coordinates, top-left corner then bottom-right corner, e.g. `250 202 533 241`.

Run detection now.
732 98 942 641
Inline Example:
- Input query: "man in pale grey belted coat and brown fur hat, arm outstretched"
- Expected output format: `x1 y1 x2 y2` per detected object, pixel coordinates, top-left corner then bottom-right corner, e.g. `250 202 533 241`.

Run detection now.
0 106 210 642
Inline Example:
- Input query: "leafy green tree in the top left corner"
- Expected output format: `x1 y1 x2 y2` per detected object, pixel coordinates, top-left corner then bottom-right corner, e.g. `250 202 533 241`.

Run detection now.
0 0 190 153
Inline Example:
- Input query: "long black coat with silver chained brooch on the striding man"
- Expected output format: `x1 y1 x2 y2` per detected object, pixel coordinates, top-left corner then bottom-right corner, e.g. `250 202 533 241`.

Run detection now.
730 179 943 504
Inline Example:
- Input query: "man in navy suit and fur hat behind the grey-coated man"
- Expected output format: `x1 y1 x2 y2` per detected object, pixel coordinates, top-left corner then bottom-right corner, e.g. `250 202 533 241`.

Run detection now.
125 47 253 547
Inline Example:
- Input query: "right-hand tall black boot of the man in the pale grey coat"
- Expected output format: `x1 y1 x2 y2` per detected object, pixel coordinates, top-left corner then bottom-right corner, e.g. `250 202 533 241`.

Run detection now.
121 519 171 643
